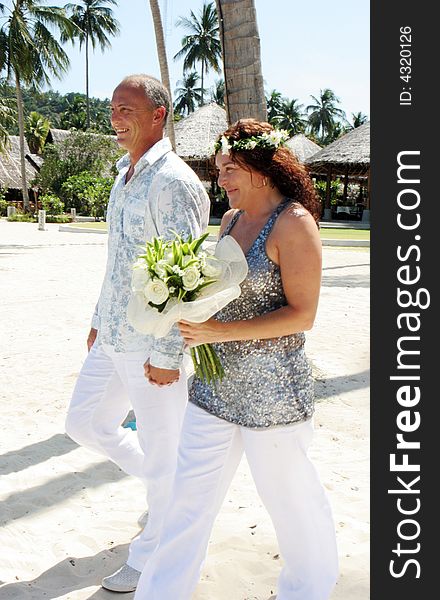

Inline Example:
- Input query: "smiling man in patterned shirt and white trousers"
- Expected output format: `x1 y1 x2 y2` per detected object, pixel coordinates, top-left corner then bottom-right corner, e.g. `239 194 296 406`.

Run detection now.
66 75 209 592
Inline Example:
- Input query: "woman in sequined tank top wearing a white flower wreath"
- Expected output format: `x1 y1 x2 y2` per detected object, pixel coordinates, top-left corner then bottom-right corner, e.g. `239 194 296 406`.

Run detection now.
135 119 337 600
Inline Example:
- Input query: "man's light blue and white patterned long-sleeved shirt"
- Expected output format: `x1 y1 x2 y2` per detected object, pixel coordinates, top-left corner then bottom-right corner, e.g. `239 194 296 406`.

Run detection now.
92 138 209 369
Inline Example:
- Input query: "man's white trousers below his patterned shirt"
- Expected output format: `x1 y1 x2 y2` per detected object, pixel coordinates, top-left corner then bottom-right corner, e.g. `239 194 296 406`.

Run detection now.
66 343 188 571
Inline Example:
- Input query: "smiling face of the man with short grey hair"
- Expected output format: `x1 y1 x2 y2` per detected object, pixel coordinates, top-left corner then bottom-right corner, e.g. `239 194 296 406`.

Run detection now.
111 83 164 154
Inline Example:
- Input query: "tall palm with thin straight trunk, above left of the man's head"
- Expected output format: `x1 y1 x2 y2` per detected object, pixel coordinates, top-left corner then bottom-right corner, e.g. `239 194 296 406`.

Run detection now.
62 0 119 128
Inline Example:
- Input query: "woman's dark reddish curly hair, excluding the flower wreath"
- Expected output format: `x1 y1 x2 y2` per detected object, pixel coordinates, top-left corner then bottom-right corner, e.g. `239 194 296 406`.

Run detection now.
218 119 321 222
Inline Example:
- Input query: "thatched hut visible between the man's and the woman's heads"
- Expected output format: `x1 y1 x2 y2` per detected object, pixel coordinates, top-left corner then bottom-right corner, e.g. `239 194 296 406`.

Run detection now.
175 102 228 181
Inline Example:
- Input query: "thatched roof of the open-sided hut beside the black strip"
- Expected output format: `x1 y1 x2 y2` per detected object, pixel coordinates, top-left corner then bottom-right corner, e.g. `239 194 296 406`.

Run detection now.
306 122 370 177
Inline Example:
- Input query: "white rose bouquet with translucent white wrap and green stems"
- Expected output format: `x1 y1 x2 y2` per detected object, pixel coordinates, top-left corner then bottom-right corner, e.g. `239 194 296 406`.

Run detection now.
127 232 248 383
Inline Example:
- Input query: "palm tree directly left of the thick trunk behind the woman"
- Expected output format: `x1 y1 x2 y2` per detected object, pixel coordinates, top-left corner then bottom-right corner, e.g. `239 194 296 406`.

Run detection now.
174 2 222 104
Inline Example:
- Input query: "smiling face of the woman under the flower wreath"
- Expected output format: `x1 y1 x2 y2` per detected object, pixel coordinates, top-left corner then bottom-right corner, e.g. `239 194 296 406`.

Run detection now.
215 152 264 208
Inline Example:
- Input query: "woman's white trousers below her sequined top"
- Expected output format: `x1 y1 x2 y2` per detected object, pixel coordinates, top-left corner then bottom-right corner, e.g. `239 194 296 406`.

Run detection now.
135 403 338 600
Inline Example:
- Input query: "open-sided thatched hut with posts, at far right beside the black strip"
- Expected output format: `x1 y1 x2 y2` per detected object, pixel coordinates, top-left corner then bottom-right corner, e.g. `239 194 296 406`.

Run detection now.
305 122 370 221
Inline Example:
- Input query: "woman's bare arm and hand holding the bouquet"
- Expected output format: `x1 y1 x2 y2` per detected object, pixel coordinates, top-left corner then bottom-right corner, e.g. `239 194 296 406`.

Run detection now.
179 207 321 346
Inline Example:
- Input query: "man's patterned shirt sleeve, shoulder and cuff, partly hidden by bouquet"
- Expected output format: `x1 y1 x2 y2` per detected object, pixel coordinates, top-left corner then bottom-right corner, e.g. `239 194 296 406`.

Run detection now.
150 179 209 369
